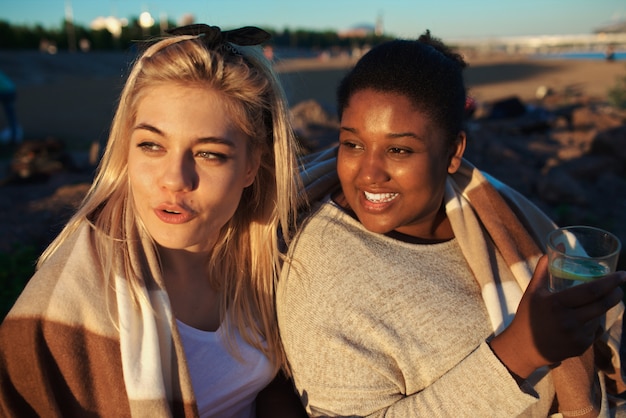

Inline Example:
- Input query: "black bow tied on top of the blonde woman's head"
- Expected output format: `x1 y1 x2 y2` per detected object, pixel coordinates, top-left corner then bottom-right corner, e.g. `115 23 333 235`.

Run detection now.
166 23 271 47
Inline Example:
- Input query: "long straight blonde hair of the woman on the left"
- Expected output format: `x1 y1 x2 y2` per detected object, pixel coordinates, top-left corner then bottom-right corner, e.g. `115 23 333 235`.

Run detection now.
38 35 300 370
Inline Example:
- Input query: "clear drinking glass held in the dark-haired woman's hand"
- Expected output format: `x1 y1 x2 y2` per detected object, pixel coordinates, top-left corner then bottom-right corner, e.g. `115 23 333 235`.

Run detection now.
547 226 622 292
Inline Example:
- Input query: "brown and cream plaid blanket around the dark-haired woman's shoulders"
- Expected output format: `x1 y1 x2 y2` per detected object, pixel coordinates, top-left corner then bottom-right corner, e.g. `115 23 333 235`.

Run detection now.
301 148 626 417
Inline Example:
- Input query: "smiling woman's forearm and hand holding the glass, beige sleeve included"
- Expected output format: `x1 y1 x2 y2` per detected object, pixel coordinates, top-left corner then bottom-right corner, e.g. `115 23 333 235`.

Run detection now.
360 257 626 417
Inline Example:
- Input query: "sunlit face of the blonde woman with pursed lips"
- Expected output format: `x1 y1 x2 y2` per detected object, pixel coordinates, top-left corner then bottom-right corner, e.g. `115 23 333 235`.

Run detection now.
128 83 258 252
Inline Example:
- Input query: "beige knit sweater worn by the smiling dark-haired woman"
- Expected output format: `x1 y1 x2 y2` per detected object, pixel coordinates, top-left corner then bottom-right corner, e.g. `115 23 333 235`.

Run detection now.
277 200 554 417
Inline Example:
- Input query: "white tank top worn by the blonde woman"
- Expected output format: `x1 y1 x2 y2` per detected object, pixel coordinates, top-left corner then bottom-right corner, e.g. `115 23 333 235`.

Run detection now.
176 320 273 418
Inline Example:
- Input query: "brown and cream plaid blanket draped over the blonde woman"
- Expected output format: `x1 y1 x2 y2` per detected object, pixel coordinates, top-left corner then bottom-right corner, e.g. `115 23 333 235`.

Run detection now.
0 225 197 417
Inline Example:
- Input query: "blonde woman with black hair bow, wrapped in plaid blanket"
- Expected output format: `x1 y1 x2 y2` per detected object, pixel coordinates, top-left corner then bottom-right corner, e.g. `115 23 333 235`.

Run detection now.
0 25 298 417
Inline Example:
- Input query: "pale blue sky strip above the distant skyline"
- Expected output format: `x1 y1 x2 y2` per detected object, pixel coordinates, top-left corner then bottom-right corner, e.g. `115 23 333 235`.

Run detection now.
0 0 626 40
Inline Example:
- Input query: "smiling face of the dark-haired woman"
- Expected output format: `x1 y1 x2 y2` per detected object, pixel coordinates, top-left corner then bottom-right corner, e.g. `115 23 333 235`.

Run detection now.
337 90 460 238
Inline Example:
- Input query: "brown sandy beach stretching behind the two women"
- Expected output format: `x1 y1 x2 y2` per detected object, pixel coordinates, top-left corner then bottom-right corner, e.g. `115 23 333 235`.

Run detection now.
0 51 626 145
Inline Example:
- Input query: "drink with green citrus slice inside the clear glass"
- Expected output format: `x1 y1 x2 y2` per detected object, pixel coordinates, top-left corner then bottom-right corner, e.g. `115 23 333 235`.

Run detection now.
549 258 611 292
